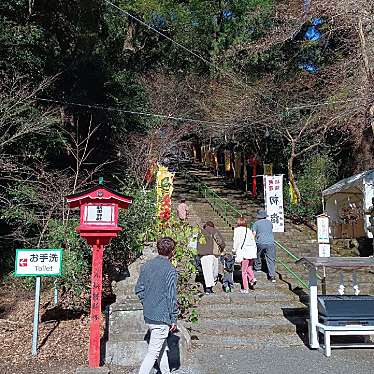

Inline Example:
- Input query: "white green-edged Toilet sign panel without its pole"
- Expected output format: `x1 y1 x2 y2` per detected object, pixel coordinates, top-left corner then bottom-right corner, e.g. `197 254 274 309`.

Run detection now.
15 249 62 277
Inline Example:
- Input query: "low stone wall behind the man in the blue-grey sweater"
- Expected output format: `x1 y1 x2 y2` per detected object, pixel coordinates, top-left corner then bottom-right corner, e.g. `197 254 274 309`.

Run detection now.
106 243 191 368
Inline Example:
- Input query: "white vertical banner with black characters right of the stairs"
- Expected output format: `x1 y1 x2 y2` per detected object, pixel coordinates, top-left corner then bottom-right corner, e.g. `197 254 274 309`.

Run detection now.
264 175 284 232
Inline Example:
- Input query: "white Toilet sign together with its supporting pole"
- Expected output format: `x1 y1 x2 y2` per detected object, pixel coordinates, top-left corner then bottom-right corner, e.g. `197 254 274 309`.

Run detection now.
15 249 62 355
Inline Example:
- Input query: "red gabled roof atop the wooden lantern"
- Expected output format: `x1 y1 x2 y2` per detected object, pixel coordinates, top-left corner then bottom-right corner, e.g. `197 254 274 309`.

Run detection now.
66 181 132 208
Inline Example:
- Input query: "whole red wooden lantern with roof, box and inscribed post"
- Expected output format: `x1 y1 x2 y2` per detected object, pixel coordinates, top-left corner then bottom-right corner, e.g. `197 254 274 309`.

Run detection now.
66 180 132 368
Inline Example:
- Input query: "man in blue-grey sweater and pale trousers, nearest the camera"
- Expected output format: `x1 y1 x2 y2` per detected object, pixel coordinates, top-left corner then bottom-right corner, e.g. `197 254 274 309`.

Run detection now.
135 238 178 374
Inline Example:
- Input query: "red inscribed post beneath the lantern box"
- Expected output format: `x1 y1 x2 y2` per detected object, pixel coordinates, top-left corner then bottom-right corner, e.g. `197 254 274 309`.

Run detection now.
88 245 104 368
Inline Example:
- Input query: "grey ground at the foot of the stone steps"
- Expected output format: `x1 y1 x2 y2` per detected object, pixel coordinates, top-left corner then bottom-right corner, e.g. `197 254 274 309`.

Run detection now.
175 346 374 374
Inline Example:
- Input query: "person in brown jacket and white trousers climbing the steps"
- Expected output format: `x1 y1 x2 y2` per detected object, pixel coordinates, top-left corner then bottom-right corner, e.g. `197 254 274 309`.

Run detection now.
197 221 226 294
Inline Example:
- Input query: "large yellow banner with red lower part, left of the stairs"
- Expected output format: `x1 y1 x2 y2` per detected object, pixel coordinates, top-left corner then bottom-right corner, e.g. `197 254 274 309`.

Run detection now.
157 165 174 221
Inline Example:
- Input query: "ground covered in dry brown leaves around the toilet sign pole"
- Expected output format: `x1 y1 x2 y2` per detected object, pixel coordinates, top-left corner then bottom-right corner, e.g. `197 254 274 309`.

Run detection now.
0 285 89 374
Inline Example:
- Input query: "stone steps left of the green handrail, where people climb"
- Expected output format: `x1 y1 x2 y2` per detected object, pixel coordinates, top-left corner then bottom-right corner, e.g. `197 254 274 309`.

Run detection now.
171 168 307 373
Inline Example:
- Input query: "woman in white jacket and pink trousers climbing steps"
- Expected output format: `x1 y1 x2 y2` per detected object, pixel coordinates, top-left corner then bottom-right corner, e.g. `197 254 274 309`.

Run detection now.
234 217 257 293
